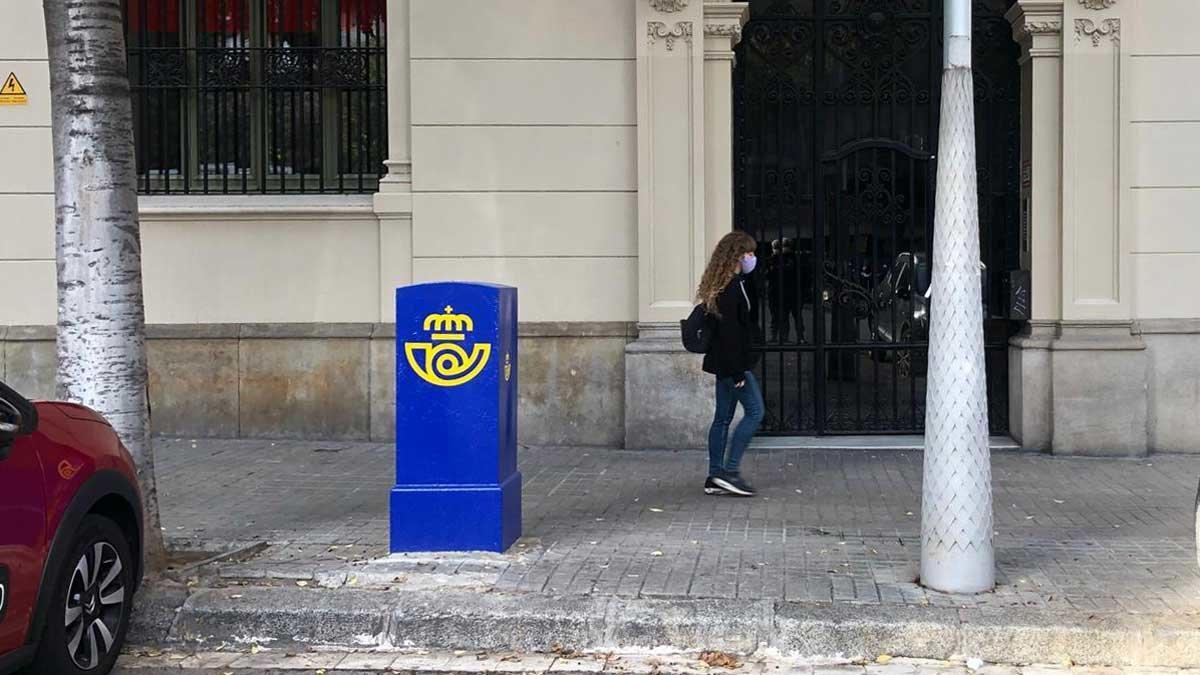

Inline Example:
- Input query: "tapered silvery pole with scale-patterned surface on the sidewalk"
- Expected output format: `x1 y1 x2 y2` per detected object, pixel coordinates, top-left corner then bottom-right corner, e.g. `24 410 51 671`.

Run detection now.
920 0 996 593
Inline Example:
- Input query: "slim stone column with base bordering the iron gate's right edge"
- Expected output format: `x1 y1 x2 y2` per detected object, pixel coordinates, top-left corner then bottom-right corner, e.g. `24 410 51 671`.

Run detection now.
1007 0 1063 449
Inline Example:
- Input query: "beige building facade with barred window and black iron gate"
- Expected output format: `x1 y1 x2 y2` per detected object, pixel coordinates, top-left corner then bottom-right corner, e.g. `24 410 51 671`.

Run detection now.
0 0 1200 455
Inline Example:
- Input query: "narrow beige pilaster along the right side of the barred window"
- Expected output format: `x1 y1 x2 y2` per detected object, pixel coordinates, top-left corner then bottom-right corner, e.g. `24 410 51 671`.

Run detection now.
374 0 413 323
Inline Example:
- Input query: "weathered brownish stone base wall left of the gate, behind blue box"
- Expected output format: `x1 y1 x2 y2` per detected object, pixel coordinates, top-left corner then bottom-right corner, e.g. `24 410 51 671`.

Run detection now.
0 323 636 447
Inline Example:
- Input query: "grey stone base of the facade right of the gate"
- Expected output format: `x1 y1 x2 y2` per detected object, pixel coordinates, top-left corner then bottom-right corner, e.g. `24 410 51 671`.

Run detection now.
1009 319 1200 456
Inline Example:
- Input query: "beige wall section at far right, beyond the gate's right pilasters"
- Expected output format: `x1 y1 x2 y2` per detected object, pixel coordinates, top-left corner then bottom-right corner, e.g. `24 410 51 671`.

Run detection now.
1122 0 1200 318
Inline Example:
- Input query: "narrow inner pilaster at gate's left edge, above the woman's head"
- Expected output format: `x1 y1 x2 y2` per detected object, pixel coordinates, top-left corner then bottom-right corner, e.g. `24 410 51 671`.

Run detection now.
704 0 748 256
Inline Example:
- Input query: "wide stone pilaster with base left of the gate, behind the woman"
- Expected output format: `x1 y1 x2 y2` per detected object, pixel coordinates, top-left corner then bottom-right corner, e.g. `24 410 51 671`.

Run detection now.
625 0 745 448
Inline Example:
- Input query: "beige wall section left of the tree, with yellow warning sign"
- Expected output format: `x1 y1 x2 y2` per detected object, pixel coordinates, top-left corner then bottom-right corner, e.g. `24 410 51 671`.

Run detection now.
0 2 55 324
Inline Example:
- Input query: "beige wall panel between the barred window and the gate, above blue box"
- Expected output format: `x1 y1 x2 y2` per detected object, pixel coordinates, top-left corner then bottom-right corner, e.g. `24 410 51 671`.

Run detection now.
408 0 637 322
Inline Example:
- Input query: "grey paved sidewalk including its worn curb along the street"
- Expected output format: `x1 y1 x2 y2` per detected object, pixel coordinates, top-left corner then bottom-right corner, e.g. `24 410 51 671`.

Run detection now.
129 440 1200 665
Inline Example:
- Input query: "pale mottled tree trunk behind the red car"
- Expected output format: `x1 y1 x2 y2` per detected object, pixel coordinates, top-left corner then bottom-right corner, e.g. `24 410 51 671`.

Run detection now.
43 0 163 572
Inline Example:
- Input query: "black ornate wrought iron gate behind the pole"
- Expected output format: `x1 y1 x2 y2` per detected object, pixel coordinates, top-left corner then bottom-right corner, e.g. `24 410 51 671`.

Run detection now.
733 0 1020 435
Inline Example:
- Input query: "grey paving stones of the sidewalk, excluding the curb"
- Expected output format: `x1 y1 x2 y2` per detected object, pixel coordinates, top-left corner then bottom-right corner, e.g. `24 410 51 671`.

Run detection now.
154 438 1200 614
